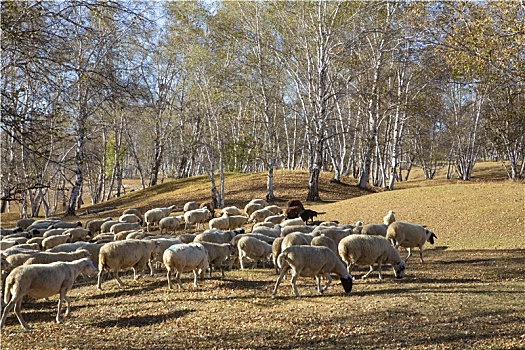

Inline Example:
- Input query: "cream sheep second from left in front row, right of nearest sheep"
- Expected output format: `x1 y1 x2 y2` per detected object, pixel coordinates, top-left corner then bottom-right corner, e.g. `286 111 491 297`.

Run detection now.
97 240 160 289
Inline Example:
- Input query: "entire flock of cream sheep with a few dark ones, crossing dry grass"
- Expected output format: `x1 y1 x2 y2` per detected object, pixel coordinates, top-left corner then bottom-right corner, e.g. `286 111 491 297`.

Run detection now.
0 199 437 328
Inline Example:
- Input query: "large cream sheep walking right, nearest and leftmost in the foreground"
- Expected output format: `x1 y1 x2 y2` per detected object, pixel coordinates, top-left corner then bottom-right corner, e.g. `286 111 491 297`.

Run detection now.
0 258 96 329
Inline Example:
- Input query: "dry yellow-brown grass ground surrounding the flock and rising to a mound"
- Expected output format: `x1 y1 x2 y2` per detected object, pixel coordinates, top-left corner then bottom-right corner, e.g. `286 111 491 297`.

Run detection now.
1 163 525 349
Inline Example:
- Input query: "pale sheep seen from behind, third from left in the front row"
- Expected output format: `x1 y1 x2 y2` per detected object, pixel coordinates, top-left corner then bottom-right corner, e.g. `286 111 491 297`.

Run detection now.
162 243 209 290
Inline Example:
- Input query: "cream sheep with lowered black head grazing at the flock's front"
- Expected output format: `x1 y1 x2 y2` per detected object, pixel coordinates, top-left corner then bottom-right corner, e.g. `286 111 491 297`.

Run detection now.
272 245 352 298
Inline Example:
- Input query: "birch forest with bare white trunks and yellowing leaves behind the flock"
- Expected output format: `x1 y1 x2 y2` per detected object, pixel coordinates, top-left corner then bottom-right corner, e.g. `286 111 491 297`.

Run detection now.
0 0 525 216
